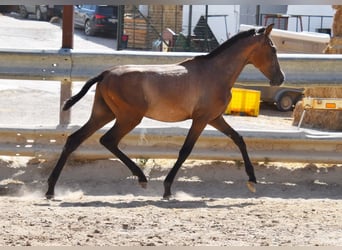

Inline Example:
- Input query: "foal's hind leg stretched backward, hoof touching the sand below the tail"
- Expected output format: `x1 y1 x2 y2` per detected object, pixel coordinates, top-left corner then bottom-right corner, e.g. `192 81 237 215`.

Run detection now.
45 91 115 199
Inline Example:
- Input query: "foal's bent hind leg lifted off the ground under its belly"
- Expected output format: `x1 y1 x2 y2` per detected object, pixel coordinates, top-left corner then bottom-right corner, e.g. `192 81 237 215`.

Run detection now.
100 118 147 188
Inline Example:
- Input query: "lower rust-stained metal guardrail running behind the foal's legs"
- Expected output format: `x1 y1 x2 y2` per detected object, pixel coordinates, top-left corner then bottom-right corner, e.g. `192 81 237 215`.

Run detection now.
0 127 342 164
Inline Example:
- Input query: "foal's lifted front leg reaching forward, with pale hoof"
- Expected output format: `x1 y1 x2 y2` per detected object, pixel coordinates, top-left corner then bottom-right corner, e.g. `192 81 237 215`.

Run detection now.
209 116 256 192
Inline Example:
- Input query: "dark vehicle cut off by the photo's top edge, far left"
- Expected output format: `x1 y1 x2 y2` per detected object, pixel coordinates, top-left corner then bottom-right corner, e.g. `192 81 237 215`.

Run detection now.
19 4 63 21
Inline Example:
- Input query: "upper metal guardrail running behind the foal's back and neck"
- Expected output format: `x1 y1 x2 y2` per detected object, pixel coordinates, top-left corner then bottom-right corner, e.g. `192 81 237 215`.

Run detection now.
0 49 342 83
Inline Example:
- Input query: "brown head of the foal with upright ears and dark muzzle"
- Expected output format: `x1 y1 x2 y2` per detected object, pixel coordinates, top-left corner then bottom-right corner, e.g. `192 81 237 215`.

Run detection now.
249 24 285 86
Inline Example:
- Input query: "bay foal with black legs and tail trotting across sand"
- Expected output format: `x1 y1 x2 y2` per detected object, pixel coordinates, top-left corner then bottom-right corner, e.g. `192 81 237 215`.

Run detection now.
46 24 284 199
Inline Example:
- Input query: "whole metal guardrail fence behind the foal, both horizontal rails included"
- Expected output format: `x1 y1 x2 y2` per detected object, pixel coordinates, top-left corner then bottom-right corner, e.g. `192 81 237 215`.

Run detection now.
0 49 342 163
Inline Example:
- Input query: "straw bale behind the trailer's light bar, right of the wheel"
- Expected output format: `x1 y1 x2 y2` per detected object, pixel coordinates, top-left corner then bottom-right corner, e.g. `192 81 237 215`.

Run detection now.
293 87 342 131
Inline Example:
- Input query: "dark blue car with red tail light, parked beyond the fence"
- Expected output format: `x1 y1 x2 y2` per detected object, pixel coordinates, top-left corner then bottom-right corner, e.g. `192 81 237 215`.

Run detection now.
74 4 118 37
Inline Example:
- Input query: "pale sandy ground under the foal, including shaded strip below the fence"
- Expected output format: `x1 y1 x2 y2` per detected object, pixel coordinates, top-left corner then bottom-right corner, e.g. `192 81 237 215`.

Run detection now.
0 158 342 246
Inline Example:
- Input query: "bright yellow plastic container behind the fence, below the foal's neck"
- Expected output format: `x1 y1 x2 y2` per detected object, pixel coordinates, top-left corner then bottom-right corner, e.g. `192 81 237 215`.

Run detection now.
225 88 260 116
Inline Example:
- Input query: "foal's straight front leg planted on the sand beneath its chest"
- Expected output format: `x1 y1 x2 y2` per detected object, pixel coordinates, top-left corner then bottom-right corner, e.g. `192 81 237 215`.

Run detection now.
163 121 207 199
